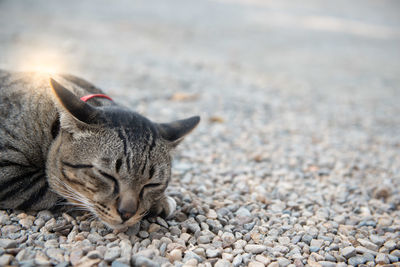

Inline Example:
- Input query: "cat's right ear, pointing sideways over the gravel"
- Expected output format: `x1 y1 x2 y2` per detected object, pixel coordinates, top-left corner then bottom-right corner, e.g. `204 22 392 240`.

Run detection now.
157 116 200 146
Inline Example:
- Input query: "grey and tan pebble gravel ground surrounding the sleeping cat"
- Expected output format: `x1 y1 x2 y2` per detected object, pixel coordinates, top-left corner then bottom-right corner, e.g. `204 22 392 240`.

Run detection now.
0 0 400 267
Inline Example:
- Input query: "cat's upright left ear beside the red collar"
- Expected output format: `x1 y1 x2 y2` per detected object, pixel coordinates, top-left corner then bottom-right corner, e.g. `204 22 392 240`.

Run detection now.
50 78 98 124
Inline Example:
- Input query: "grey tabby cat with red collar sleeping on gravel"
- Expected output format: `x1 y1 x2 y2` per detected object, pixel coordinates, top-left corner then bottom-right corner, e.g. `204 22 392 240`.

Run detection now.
0 70 200 229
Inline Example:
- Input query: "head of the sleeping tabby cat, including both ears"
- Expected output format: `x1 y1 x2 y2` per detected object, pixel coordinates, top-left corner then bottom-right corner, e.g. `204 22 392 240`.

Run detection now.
47 80 200 229
